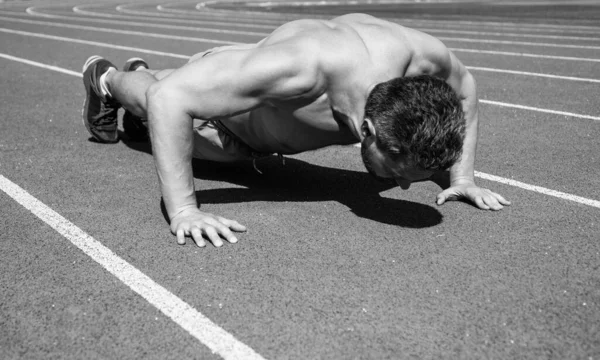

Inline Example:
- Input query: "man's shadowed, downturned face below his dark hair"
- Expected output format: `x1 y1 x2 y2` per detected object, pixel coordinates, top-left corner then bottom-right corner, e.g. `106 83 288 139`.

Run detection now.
361 136 433 190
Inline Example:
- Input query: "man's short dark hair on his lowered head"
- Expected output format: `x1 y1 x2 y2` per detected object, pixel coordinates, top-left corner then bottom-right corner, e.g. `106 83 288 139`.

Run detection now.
365 75 465 171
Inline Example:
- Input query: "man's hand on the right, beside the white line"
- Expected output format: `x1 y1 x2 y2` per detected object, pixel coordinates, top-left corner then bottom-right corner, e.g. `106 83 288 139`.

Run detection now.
436 182 510 210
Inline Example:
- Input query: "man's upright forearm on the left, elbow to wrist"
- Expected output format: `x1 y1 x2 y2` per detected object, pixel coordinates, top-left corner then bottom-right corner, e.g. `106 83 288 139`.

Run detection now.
148 88 197 219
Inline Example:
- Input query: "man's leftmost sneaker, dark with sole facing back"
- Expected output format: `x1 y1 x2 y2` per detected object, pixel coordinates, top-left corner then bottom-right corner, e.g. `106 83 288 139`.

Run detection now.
82 55 120 143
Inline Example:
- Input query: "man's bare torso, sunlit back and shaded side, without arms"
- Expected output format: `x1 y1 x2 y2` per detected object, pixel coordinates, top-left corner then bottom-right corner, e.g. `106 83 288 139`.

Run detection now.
194 14 446 154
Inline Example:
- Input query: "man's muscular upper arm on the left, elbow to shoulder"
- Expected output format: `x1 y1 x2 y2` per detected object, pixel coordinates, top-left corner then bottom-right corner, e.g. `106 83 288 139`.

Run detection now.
157 48 322 119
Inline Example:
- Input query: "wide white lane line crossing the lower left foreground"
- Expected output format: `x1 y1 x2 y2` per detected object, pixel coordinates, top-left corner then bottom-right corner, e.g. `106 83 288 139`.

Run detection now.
0 175 263 360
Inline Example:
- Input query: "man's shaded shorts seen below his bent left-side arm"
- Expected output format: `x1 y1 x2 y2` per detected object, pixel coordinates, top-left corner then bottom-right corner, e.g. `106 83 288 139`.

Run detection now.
193 119 272 162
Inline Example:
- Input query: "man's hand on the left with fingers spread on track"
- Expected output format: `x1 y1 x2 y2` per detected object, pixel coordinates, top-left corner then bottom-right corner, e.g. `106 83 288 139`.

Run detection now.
171 207 246 247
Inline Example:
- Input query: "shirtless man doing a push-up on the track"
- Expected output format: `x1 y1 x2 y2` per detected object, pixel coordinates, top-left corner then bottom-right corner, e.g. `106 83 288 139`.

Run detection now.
83 14 510 247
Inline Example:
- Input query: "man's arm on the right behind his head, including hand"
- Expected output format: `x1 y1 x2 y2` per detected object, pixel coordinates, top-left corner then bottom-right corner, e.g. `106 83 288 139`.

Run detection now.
436 51 510 210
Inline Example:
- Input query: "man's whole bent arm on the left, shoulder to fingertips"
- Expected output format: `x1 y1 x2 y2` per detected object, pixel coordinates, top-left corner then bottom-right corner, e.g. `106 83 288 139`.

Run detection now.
147 44 315 246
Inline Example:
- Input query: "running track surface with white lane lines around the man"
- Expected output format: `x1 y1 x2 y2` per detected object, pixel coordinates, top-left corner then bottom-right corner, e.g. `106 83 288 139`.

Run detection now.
0 0 600 359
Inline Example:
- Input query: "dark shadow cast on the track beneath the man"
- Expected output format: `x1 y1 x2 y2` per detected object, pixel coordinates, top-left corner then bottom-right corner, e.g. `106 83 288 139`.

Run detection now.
123 140 449 228
